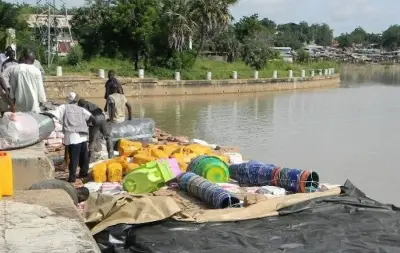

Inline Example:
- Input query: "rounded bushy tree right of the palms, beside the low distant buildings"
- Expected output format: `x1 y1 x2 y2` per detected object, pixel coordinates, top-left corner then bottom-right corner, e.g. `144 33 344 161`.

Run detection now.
243 33 278 71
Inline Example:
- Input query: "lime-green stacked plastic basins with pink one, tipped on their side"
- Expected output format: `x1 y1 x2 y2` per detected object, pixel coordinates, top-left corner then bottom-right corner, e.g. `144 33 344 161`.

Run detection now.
122 159 182 194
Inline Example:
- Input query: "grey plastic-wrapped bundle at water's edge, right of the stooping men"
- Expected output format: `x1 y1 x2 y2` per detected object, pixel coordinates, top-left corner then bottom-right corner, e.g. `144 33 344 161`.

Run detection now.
111 118 156 142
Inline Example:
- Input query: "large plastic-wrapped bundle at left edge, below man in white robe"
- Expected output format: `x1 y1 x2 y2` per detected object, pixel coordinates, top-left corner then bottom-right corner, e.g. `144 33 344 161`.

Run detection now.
0 112 54 150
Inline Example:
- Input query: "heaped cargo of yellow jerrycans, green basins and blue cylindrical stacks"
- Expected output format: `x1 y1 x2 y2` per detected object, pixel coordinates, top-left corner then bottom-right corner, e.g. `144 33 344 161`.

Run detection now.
79 136 328 209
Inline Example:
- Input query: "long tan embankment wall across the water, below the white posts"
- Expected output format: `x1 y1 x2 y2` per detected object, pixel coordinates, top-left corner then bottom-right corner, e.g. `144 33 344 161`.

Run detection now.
45 74 340 99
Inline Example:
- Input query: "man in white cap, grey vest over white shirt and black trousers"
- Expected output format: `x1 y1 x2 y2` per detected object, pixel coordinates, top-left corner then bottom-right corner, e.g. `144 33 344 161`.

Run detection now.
46 92 92 183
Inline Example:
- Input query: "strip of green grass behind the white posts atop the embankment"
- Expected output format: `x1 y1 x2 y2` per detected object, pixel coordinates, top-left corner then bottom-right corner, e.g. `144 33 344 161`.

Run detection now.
46 58 340 80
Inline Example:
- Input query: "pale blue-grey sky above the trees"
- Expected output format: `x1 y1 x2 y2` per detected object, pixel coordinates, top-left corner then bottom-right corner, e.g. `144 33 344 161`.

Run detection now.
9 0 400 36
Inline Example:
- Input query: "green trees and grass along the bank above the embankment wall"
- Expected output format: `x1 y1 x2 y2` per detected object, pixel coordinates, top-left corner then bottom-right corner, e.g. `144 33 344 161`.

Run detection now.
0 0 344 79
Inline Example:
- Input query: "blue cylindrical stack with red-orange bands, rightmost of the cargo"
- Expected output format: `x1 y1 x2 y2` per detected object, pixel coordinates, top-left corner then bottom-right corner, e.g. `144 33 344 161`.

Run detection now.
229 161 319 193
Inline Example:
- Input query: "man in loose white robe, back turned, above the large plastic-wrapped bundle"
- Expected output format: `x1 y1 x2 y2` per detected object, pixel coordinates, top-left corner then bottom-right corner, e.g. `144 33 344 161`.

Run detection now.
9 51 47 113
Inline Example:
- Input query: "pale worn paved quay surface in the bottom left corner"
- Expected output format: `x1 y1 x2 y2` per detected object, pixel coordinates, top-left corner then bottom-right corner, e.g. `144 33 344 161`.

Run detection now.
0 190 100 253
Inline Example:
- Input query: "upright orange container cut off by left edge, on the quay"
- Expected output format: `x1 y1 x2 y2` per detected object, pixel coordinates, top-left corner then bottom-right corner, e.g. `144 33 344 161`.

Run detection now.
0 152 14 196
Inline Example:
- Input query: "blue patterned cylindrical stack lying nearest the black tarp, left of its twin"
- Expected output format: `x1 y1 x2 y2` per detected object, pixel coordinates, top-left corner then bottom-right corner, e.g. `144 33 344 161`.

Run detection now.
178 172 240 209
